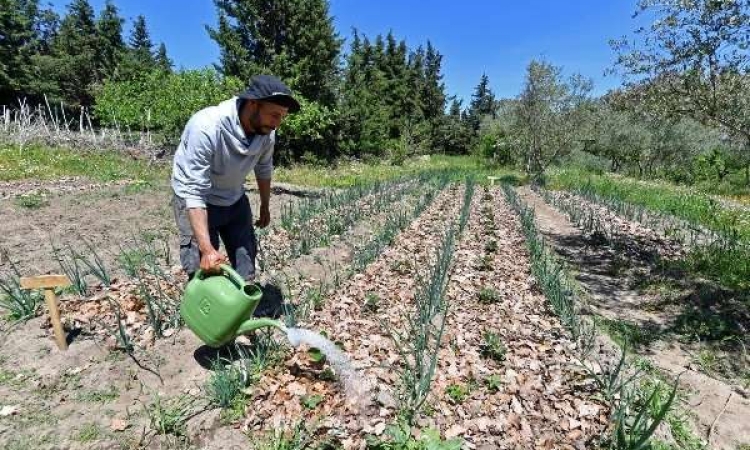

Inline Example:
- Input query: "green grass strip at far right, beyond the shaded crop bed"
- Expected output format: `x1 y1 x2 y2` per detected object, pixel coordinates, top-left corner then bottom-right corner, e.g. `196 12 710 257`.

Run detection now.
549 170 750 242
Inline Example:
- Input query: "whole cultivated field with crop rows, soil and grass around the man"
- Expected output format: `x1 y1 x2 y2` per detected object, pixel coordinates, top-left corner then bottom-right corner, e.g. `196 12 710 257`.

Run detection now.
0 149 750 450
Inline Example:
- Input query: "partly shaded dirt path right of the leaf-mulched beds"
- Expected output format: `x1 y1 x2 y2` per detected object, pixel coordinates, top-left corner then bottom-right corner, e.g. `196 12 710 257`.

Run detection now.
518 187 750 450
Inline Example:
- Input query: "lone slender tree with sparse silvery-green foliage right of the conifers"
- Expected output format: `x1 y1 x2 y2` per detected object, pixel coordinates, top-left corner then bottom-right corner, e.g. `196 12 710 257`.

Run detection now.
514 61 592 179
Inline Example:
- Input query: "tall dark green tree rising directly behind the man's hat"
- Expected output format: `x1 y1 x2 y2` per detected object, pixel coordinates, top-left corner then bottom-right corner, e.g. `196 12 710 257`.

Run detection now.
207 0 342 106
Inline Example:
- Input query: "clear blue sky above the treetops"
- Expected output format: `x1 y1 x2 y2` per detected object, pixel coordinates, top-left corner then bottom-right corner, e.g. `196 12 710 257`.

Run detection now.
52 0 648 104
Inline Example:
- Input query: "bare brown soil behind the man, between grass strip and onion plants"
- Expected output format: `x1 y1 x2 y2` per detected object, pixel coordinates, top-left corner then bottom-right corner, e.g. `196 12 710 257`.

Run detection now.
0 182 300 275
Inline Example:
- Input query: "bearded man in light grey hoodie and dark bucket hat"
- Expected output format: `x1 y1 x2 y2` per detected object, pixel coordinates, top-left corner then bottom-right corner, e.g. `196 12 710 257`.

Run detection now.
172 75 300 281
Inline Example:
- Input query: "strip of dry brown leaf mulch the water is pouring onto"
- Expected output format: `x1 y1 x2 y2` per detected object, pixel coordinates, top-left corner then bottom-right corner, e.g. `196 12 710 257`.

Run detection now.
245 184 461 447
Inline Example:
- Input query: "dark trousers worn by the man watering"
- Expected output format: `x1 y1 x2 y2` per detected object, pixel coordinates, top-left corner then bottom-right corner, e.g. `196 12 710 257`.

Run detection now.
172 195 257 281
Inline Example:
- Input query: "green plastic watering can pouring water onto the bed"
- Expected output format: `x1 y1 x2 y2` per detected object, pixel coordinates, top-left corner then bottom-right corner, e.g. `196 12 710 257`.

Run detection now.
180 264 284 348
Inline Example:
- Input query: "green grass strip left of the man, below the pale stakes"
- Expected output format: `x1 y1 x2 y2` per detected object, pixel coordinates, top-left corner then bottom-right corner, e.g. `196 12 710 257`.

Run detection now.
0 145 169 183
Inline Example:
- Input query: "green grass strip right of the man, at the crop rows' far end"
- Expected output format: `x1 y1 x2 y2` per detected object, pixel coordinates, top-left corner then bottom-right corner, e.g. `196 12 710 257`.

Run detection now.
274 155 526 188
